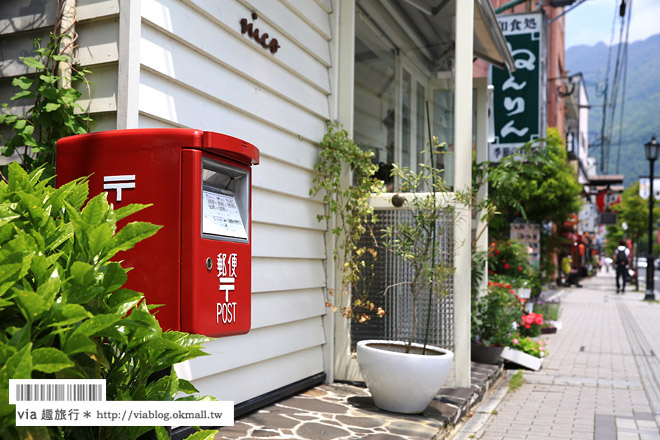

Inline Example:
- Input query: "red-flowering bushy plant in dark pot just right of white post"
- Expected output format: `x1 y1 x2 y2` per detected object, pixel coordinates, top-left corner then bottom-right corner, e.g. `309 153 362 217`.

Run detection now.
471 281 522 364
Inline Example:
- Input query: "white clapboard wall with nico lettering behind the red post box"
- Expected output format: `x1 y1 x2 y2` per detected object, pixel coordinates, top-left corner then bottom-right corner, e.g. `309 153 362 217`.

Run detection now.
0 0 332 404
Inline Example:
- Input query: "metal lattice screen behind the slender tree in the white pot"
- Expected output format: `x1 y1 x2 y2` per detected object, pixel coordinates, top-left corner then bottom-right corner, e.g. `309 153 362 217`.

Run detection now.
351 209 454 350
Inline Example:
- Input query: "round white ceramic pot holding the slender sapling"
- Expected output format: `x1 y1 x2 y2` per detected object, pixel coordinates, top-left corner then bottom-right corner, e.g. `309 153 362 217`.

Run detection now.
357 340 454 414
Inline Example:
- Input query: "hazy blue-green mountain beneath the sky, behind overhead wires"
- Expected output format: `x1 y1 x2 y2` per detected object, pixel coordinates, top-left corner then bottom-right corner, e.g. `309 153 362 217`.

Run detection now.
566 34 660 186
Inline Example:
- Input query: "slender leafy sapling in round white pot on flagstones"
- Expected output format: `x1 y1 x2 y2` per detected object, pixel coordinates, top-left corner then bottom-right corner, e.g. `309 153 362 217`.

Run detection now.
357 139 454 414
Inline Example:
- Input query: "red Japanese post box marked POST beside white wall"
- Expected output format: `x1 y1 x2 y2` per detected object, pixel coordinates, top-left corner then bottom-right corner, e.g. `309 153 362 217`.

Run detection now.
56 128 259 336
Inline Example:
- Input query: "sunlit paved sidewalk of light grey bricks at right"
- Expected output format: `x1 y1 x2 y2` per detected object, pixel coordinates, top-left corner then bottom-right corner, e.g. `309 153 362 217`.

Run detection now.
451 271 660 440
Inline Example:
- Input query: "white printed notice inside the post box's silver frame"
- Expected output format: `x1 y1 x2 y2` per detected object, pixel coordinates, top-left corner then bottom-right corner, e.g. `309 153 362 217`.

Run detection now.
202 190 248 240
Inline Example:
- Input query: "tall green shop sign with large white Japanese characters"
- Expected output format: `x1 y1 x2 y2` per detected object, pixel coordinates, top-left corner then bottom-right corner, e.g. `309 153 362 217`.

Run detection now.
489 12 546 162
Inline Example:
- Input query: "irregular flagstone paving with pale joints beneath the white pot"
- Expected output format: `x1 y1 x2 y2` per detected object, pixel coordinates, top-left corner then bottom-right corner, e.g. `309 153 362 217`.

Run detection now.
215 363 503 440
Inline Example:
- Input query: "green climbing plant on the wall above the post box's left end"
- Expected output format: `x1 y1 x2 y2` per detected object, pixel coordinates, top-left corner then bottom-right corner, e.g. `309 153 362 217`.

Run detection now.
0 33 91 177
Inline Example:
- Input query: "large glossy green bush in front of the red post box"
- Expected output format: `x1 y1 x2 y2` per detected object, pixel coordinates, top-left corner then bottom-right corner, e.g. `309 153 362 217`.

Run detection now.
0 162 217 440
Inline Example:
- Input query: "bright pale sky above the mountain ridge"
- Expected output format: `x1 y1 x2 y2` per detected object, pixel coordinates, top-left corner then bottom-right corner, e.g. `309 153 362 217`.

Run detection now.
565 0 660 49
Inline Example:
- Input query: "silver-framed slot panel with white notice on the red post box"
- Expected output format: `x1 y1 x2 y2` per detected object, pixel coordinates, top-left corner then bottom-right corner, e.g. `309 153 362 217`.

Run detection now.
201 158 250 242
